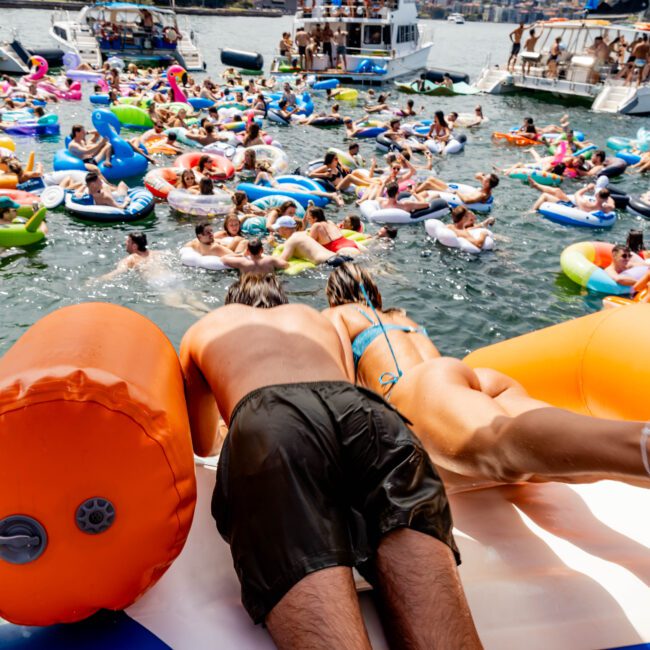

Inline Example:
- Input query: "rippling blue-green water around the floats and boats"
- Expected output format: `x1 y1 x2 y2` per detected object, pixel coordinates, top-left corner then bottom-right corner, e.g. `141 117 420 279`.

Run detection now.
0 10 650 356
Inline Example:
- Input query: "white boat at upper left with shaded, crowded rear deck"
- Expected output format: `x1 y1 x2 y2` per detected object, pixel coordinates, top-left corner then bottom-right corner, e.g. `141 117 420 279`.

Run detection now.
50 2 205 70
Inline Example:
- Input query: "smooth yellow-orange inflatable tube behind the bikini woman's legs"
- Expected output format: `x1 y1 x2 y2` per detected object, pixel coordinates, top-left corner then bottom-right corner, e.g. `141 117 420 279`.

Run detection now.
465 304 650 420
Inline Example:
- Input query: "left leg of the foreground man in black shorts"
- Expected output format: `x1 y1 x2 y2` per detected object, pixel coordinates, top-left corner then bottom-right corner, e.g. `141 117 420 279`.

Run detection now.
265 566 370 650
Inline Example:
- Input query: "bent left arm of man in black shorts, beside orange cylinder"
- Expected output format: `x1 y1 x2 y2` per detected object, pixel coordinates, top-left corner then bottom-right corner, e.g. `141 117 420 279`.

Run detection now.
180 330 219 456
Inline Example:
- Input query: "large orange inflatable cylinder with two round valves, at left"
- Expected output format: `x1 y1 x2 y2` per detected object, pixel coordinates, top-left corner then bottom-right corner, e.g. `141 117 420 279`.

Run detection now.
0 303 196 625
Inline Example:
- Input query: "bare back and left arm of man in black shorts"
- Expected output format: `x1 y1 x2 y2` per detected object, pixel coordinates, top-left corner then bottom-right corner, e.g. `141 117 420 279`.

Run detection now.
180 305 347 451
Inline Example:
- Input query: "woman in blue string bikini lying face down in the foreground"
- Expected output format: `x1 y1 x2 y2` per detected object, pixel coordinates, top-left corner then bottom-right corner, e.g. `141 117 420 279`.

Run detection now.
324 263 650 494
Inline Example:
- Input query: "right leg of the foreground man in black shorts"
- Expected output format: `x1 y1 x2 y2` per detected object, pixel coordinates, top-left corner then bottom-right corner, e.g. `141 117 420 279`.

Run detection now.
377 528 483 650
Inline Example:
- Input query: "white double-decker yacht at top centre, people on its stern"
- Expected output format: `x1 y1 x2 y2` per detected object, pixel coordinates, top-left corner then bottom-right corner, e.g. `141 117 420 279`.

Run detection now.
271 0 432 85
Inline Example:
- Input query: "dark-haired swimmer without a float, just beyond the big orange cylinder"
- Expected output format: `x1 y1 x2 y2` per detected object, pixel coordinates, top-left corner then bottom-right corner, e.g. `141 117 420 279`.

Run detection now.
98 232 210 318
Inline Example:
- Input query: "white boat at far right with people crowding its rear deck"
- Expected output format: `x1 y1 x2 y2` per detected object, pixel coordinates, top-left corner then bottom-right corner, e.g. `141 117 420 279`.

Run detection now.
474 19 650 115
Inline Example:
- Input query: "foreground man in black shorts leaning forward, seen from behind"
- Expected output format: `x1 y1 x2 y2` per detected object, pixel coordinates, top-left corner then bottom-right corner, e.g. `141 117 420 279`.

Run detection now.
180 275 481 650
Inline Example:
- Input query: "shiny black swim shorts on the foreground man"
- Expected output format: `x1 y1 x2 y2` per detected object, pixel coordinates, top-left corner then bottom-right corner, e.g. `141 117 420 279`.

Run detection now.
212 382 460 623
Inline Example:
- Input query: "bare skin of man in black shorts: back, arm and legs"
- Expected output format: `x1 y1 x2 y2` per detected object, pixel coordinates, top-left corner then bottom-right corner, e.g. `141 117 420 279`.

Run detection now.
180 305 481 650
